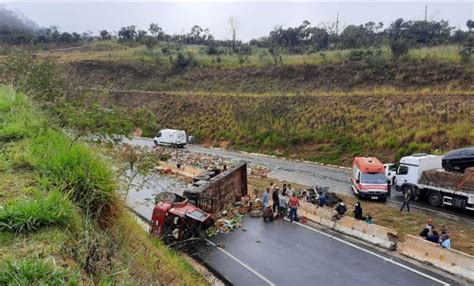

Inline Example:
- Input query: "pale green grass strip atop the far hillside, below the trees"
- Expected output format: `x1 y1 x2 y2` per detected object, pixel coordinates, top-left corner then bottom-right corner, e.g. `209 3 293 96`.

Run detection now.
36 41 470 68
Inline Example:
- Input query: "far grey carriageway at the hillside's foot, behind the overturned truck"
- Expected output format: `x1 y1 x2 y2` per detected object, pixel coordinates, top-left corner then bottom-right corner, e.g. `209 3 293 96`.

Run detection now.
125 138 474 225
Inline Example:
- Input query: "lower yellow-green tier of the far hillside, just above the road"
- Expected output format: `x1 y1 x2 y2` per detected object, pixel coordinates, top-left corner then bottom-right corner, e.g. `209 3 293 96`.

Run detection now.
109 92 474 164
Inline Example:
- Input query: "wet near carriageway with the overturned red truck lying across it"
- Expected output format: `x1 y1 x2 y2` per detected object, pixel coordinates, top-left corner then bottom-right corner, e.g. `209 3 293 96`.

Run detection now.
126 190 456 286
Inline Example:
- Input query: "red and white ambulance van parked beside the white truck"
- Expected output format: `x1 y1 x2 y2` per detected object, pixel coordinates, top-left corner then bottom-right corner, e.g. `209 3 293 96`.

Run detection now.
351 157 388 201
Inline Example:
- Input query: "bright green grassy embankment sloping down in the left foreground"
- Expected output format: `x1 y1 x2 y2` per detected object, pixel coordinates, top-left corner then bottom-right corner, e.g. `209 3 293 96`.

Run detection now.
0 86 206 285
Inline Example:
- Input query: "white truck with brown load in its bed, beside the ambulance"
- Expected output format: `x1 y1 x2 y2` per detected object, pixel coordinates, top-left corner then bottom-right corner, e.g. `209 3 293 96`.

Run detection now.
395 154 474 210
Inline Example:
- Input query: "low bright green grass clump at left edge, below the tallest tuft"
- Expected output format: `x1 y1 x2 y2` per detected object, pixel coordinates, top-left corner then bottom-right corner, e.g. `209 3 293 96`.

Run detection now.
0 191 74 233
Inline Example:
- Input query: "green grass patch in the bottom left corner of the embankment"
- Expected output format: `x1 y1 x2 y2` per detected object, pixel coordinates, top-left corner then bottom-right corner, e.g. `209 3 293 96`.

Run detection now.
0 258 77 285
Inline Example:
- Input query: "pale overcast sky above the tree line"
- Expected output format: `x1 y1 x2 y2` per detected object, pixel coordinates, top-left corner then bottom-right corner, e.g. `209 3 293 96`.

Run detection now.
0 0 474 41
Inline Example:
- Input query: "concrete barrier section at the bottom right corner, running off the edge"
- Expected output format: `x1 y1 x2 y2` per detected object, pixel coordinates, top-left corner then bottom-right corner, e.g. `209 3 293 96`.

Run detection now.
397 235 474 282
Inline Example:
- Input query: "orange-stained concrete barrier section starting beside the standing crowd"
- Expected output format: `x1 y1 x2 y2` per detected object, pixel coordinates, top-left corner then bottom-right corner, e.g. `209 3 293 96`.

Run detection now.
298 202 398 250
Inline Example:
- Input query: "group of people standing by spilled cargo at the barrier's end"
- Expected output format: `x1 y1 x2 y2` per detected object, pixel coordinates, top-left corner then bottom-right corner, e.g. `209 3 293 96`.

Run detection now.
263 183 300 222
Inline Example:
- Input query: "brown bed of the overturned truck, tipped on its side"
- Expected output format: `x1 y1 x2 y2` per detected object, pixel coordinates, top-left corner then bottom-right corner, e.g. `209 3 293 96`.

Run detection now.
183 163 248 215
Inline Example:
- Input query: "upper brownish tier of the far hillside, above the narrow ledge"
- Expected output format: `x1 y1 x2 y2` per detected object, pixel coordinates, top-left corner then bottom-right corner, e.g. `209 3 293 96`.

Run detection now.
64 55 474 94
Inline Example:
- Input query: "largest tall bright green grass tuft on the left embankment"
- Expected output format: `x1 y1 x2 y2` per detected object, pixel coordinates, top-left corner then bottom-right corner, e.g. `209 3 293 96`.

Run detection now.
29 131 116 218
